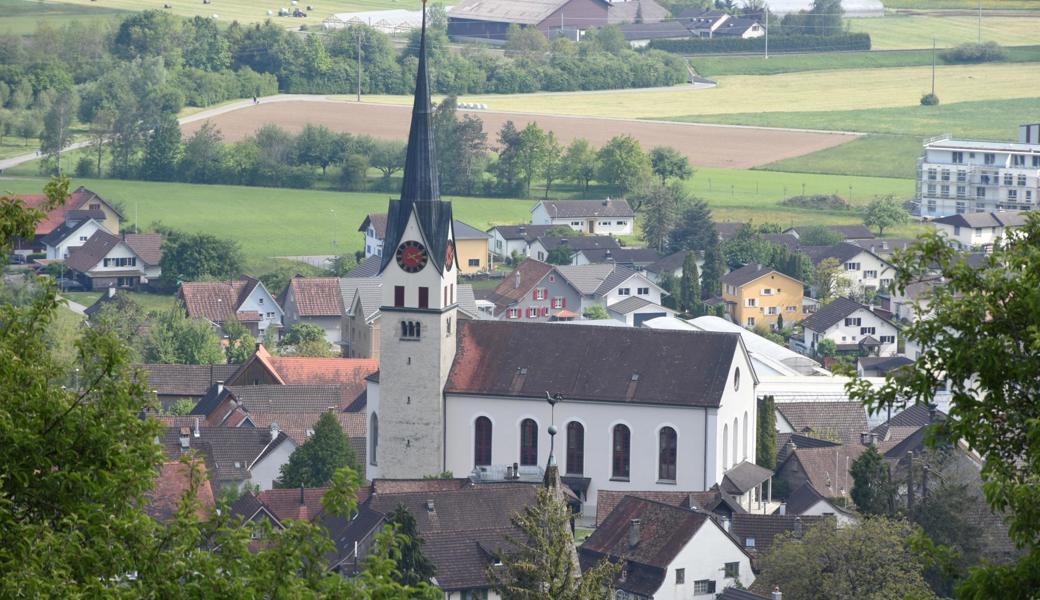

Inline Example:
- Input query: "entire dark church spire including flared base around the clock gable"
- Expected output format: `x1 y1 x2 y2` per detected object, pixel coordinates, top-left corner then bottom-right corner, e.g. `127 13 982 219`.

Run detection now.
380 1 453 272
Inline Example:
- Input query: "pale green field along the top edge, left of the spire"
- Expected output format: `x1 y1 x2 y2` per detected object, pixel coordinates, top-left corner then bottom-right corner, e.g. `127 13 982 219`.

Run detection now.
11 0 420 31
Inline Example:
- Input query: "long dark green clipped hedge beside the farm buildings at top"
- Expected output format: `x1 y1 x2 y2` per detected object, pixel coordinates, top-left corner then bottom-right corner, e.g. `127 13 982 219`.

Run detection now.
650 33 870 54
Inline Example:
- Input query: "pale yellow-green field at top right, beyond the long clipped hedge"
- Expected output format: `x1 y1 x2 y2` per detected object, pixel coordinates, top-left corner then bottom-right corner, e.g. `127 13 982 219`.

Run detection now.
848 10 1040 50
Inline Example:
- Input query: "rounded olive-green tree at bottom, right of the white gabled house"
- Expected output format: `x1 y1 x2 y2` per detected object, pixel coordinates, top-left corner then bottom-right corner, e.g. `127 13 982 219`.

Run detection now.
758 517 936 600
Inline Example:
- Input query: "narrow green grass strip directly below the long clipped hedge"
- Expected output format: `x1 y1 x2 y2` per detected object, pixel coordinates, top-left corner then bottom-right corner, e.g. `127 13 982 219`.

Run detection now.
690 46 1040 77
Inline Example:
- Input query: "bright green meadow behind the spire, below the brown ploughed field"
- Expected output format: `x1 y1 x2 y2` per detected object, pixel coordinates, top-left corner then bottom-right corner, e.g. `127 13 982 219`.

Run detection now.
0 178 535 257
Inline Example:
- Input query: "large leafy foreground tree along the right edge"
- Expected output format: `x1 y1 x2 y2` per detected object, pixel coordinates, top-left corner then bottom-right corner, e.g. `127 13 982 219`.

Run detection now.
851 215 1040 598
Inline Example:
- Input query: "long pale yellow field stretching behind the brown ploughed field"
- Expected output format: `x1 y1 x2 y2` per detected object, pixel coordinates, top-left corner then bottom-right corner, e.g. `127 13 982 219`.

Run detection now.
405 63 1040 119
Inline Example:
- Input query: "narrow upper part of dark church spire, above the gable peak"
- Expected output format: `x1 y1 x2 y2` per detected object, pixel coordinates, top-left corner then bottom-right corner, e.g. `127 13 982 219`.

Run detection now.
400 0 441 205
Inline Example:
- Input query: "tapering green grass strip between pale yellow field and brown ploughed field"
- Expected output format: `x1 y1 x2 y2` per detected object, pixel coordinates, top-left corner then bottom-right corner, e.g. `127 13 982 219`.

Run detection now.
668 98 1040 139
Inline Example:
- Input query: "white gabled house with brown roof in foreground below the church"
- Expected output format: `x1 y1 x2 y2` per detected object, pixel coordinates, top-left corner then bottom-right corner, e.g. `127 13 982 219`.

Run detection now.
578 496 755 600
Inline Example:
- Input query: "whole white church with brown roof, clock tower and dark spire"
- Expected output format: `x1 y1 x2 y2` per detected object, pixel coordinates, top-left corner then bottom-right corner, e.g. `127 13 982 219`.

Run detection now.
366 7 758 514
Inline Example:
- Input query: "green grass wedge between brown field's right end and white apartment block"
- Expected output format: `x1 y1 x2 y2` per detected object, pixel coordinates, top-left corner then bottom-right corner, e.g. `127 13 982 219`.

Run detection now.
758 135 921 179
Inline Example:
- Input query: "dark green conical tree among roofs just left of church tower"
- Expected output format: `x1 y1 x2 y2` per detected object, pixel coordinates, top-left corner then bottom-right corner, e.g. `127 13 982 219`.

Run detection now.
275 412 360 488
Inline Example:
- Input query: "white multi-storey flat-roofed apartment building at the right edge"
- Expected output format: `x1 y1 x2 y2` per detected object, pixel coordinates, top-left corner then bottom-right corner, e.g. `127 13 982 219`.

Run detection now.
917 125 1040 217
